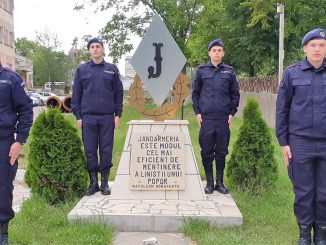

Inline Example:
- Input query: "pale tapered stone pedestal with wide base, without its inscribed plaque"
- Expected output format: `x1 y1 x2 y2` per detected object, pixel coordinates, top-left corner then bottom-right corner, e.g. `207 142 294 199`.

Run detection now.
68 120 243 232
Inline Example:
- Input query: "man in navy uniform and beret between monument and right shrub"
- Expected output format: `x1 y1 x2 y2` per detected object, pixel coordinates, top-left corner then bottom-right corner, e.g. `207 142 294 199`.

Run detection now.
192 39 240 194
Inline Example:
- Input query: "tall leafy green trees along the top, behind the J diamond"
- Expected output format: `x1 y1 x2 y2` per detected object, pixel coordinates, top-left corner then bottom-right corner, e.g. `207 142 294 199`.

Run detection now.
76 0 326 76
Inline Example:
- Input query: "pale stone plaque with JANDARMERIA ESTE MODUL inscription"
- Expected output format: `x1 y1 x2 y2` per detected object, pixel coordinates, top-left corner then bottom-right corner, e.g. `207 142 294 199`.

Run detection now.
130 132 186 191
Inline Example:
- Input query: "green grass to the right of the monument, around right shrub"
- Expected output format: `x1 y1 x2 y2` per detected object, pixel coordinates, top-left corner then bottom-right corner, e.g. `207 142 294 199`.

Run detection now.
183 104 298 245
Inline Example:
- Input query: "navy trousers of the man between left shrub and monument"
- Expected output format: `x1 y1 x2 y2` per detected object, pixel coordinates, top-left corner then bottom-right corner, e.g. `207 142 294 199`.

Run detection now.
82 114 115 174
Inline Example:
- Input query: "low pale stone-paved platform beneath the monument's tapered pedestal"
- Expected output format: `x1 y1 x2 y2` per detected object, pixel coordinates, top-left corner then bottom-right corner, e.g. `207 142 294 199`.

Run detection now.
68 183 243 232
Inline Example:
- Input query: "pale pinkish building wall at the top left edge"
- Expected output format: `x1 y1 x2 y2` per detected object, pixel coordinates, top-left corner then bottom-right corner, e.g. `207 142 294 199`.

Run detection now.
0 0 16 70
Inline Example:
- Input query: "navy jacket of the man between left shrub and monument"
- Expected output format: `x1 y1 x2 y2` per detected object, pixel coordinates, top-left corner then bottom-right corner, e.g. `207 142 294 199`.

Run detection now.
71 60 123 120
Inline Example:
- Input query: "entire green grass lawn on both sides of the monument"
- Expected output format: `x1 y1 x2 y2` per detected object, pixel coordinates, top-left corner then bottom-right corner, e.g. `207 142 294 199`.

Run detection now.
10 105 298 245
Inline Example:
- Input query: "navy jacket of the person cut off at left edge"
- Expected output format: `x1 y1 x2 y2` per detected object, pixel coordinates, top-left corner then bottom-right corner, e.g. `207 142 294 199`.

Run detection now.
0 64 33 143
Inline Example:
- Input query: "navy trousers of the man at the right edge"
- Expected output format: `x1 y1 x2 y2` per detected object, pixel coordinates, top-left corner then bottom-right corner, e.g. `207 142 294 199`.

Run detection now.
288 137 326 225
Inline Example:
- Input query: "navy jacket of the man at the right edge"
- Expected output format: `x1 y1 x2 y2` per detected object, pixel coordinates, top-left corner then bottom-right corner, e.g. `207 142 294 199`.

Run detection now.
275 59 326 146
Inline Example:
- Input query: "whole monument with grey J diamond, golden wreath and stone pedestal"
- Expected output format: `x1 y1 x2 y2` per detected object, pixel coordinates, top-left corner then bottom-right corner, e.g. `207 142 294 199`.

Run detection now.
68 15 242 232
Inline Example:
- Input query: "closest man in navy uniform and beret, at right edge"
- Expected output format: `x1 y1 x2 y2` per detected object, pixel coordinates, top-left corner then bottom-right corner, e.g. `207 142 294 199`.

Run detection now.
276 29 326 245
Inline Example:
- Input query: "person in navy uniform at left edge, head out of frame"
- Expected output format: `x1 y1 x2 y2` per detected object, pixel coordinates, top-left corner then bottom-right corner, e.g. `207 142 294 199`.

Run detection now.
0 63 33 244
